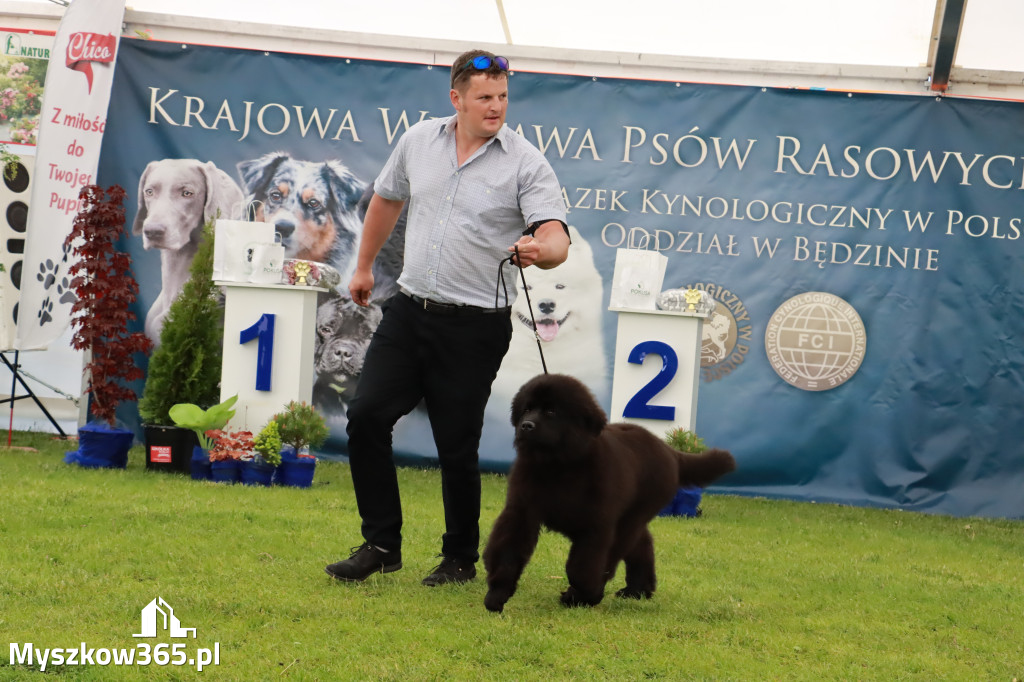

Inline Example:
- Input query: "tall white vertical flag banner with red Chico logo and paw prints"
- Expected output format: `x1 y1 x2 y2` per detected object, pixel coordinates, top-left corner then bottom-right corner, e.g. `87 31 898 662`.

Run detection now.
14 0 125 350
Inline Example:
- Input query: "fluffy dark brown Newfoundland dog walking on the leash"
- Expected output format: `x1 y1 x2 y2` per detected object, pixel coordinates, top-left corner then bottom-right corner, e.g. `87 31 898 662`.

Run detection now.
483 374 736 611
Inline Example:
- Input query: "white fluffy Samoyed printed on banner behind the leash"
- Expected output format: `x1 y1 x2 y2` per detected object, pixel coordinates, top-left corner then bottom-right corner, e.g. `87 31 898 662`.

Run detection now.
487 225 609 411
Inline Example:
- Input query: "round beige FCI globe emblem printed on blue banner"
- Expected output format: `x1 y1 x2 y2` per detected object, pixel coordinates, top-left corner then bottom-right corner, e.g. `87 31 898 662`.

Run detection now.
765 291 867 391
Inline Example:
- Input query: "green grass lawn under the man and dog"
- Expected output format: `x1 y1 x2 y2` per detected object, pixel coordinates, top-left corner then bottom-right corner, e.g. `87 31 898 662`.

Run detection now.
0 433 1024 682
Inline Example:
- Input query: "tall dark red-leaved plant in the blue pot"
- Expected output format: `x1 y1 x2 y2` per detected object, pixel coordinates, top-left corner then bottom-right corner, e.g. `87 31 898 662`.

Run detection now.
65 184 153 426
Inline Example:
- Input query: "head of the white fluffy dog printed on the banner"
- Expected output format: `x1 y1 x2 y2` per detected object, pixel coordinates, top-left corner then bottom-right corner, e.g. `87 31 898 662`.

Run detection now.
512 225 604 343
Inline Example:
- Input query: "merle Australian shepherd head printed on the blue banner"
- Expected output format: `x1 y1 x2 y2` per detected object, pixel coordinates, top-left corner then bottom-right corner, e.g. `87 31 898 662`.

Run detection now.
238 153 366 262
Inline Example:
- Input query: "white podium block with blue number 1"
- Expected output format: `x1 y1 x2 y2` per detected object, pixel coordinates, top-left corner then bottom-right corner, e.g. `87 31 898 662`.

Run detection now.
216 282 327 434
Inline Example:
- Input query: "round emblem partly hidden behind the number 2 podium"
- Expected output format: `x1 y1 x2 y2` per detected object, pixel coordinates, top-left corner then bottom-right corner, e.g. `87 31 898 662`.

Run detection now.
683 282 753 383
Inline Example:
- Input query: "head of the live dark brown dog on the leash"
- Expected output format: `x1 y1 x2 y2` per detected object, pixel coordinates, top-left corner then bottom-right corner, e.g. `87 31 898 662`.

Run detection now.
512 374 608 454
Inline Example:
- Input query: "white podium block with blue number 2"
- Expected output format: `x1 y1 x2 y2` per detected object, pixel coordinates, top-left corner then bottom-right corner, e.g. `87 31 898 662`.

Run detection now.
608 308 703 438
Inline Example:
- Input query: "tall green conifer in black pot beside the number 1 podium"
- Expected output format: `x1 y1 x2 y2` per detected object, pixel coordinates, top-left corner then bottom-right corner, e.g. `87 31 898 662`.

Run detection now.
138 221 224 472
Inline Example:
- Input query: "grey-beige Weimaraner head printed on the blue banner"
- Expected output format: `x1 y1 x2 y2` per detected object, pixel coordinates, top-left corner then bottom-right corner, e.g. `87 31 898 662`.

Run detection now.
132 159 242 251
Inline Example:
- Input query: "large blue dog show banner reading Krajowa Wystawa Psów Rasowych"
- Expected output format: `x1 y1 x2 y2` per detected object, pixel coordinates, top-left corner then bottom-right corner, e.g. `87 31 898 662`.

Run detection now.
99 40 1024 517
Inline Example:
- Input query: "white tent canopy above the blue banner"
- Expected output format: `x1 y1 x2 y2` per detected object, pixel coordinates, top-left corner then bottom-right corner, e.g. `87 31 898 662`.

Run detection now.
6 0 1024 97
